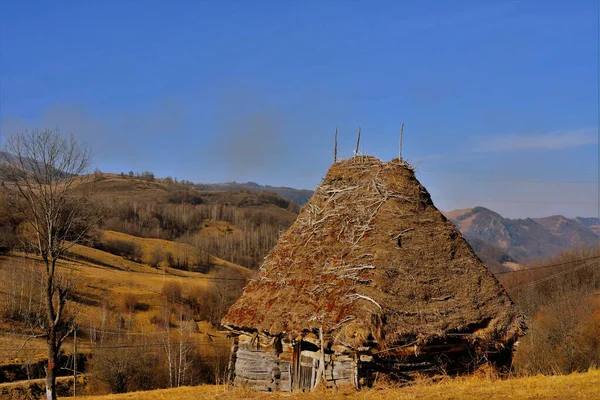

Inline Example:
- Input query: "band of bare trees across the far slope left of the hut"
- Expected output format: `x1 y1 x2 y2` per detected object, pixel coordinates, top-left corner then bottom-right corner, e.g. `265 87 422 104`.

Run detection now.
94 199 293 268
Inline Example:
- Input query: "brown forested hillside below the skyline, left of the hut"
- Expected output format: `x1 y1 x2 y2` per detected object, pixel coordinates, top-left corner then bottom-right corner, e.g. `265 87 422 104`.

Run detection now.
0 171 299 269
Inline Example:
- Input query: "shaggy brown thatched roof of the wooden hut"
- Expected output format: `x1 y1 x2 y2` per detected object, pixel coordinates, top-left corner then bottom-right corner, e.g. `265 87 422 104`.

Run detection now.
222 156 523 346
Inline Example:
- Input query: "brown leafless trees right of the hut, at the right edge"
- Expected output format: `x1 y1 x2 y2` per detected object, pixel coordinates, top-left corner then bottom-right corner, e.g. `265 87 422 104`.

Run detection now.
501 246 600 375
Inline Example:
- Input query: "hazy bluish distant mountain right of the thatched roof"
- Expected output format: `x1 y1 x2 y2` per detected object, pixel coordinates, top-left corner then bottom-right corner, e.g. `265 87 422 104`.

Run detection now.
445 207 599 262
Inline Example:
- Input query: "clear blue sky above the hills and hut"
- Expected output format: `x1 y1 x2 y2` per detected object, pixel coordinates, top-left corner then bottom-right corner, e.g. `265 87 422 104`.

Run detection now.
0 0 599 217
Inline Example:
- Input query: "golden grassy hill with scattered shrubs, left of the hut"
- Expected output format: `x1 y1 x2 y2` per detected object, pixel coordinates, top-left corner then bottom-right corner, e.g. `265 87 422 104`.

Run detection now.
0 231 253 374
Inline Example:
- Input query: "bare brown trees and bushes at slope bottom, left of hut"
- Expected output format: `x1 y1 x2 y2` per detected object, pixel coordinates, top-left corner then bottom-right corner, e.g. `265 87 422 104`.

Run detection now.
90 281 242 393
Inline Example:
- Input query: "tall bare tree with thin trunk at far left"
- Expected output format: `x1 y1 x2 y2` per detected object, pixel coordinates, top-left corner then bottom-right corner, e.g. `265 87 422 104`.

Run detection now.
0 129 94 400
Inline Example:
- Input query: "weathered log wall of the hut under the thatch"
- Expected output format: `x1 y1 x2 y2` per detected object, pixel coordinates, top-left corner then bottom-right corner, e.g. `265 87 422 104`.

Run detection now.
230 334 512 392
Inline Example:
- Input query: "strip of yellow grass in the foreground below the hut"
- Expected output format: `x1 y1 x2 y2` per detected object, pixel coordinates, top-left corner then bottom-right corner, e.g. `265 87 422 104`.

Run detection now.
75 370 600 400
